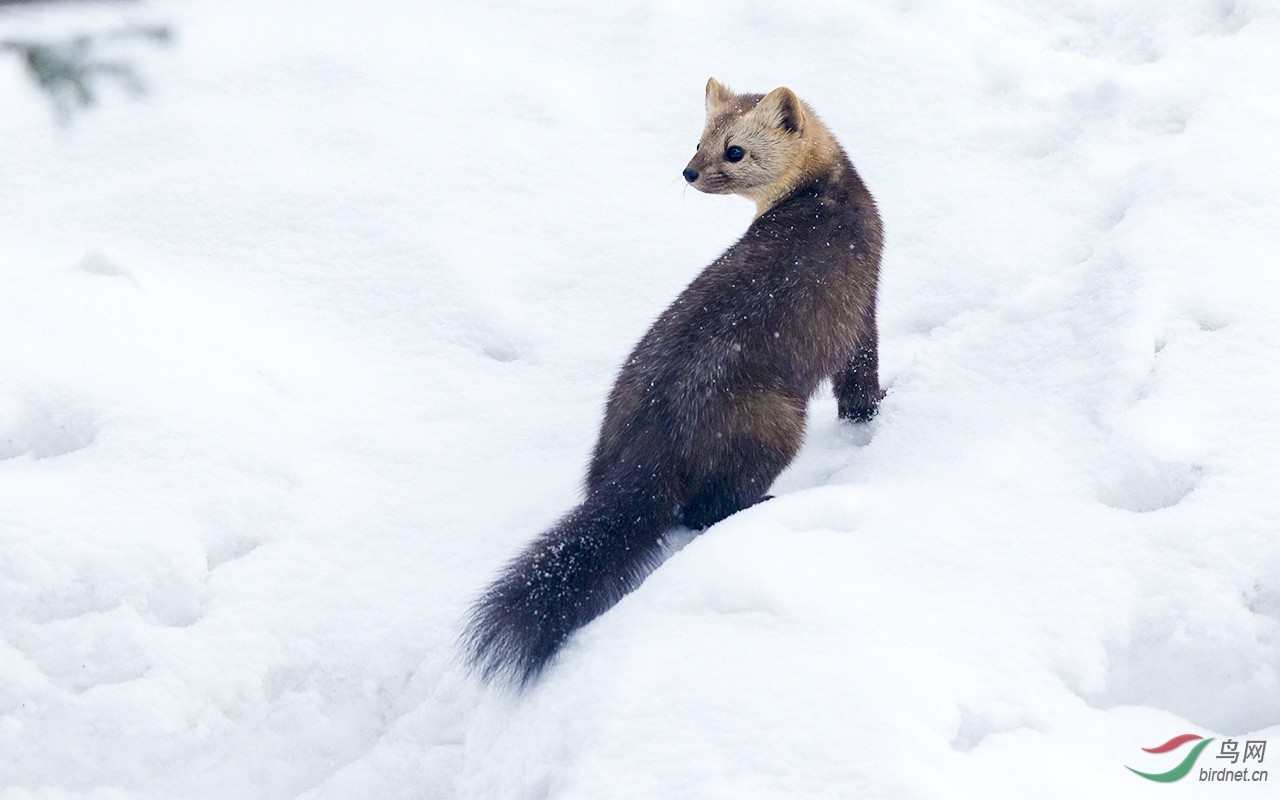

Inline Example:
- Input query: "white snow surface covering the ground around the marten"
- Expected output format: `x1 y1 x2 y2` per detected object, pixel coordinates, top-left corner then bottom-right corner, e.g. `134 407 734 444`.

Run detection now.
0 0 1280 800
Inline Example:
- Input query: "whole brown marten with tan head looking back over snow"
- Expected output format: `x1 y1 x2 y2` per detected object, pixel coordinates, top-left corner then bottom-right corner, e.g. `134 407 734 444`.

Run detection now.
462 78 883 686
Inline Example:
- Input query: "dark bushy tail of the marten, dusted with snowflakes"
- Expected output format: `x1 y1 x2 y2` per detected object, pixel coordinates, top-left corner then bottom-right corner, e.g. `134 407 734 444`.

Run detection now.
462 484 676 686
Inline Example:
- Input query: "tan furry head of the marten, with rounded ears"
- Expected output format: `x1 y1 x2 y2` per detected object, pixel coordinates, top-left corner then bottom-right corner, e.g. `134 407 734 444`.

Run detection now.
685 78 838 215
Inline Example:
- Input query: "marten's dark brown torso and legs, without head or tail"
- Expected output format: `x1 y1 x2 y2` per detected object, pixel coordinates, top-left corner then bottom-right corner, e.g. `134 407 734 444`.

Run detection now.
586 159 881 529
